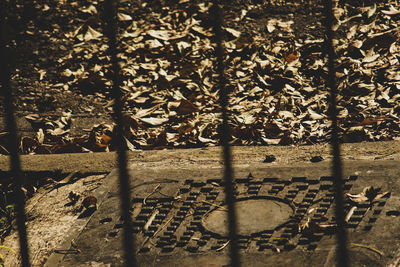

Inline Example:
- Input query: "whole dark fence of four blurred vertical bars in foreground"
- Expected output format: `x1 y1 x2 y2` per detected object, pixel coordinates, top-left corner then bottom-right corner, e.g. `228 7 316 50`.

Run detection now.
0 0 349 267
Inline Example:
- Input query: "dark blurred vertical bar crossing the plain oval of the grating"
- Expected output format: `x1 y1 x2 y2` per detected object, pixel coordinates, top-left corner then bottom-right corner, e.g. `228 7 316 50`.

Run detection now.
211 0 240 267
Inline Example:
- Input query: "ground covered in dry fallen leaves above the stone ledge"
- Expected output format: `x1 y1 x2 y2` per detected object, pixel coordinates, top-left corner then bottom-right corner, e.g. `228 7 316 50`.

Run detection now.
0 0 400 154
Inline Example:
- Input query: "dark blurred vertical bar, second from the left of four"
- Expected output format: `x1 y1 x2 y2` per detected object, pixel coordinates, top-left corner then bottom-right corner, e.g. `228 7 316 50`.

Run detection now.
104 0 136 267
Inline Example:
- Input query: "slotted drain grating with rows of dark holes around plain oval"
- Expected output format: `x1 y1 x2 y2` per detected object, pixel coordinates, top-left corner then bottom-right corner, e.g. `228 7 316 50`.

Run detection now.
126 175 389 254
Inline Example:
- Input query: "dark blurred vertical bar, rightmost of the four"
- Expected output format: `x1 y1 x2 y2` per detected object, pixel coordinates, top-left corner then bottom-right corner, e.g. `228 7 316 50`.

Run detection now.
324 0 349 267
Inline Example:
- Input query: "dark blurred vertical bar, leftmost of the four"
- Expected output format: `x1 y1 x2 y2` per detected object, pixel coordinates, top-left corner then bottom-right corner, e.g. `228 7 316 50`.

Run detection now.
0 1 30 267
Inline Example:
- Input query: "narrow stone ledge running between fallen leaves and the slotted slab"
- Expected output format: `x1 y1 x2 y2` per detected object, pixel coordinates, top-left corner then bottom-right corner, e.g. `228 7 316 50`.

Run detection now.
0 141 400 173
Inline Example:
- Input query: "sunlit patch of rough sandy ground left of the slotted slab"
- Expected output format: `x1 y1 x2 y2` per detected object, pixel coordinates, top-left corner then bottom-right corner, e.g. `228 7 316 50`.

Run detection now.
1 174 110 266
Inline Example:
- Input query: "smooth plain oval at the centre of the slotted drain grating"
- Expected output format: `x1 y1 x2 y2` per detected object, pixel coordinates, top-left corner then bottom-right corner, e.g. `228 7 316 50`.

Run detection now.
202 197 293 236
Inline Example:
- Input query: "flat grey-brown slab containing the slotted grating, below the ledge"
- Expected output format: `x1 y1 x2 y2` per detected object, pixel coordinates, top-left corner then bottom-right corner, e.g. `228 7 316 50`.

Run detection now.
46 161 400 266
